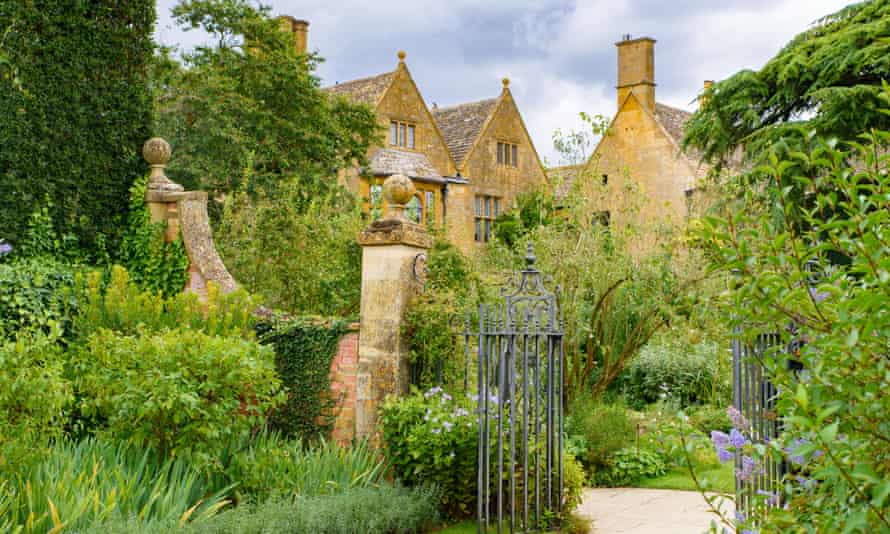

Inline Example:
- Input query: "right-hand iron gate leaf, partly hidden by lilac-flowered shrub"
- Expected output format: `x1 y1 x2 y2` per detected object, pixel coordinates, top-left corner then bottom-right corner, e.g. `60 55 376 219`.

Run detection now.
732 333 785 517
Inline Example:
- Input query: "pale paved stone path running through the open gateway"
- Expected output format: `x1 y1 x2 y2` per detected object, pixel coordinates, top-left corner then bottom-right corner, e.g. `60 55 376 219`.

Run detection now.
578 488 732 534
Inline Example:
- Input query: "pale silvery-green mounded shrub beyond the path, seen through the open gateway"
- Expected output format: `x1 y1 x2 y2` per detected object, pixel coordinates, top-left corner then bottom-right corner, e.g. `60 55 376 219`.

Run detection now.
616 335 729 408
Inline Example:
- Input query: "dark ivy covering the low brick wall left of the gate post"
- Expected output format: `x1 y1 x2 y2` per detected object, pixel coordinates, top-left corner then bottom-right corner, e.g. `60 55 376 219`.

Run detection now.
257 317 347 439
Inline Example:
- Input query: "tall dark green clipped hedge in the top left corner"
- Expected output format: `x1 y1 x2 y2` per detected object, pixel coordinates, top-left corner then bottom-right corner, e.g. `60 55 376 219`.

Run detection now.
0 0 155 255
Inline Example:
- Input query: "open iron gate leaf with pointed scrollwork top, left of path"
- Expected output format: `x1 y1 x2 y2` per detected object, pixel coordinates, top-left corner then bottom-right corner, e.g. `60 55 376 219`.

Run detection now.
465 244 563 533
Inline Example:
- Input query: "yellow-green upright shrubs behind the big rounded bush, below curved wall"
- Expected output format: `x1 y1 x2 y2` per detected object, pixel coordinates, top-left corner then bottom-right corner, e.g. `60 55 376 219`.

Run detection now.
76 265 257 339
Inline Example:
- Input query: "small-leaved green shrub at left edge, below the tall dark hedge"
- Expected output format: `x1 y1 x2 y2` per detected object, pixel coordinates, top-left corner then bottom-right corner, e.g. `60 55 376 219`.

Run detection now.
0 258 84 337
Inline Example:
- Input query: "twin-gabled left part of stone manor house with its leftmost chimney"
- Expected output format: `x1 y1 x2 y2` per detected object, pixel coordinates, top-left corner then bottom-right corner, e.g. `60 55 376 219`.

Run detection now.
281 17 547 253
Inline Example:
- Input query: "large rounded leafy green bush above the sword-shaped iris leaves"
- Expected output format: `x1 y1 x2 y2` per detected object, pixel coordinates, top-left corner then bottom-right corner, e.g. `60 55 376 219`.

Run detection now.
72 329 283 461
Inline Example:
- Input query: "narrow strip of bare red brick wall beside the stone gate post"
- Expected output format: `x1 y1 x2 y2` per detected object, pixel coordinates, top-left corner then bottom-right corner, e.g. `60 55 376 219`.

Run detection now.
329 323 359 445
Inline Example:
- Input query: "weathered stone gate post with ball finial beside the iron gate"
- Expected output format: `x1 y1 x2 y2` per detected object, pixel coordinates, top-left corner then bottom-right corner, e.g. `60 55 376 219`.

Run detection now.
355 174 432 443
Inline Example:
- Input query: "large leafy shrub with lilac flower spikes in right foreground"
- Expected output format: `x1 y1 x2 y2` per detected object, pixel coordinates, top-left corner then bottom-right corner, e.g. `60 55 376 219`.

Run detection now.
697 102 890 532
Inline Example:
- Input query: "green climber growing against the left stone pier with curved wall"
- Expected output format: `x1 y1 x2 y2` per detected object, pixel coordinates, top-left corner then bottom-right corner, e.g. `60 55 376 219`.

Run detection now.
120 176 189 297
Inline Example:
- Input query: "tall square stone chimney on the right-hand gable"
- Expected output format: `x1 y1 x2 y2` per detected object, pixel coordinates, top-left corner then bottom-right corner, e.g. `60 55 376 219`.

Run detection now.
615 35 655 111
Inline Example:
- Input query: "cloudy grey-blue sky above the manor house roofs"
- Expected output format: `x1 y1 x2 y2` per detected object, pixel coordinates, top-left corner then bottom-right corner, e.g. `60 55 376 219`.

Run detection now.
157 0 850 164
